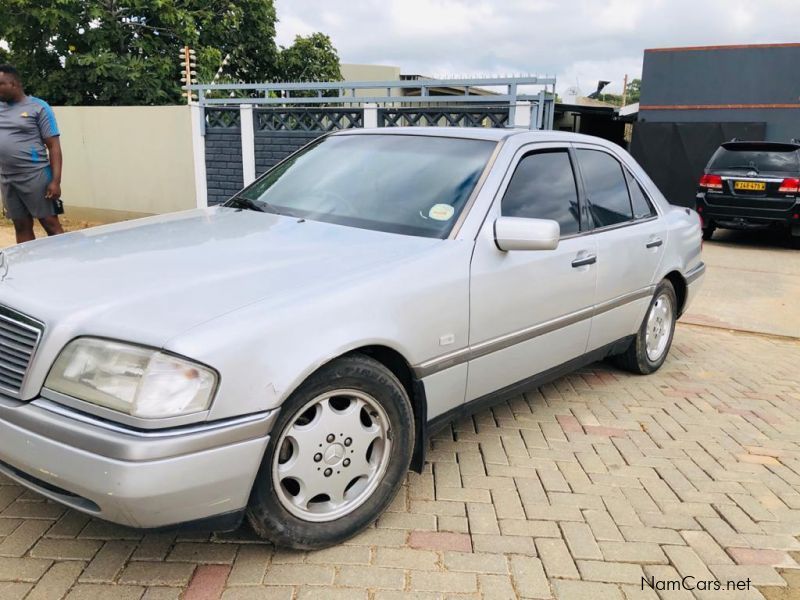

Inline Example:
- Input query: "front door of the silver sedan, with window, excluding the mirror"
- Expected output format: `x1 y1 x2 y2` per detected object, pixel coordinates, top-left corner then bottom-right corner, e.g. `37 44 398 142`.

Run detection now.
466 144 597 401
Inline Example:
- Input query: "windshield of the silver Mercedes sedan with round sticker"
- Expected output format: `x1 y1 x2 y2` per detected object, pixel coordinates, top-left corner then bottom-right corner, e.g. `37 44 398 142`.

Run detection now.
230 134 496 238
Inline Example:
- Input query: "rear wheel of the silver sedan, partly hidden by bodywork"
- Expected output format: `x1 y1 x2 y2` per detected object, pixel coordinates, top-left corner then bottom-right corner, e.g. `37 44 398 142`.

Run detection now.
614 279 678 375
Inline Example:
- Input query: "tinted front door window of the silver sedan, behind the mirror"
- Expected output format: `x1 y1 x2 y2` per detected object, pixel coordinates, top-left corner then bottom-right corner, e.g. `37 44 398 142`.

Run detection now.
501 150 580 236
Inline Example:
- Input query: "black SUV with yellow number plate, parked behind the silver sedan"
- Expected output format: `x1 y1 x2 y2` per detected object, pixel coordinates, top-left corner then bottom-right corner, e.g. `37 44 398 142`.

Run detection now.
696 140 800 240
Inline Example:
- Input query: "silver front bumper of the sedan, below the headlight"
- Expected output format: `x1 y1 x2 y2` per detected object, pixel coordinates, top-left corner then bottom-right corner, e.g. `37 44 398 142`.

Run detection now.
0 396 277 528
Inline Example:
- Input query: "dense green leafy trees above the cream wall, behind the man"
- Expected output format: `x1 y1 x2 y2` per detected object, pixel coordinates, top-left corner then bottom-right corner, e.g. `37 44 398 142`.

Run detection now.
0 0 338 105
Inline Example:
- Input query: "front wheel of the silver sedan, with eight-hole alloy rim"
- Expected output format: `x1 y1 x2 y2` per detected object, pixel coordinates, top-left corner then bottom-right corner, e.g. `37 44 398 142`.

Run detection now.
247 354 414 550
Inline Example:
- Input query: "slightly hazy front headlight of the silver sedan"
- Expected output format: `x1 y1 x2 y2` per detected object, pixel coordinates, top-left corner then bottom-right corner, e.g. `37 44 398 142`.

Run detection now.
45 338 217 419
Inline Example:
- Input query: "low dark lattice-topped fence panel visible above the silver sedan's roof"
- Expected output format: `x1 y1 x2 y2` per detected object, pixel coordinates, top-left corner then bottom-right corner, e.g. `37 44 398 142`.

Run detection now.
378 106 509 127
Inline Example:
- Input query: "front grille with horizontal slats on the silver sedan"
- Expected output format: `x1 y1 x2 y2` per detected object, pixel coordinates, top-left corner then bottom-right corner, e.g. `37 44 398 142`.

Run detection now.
0 306 44 396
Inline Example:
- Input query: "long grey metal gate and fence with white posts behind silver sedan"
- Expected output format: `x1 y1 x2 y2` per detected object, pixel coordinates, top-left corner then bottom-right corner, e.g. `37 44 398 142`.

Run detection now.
190 77 556 204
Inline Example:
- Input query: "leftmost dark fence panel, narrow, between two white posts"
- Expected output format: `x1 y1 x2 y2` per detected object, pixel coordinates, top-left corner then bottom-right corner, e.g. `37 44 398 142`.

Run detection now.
205 107 244 205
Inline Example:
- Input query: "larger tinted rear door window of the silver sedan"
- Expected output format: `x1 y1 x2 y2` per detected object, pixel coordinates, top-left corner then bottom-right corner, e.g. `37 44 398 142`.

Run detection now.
578 150 633 227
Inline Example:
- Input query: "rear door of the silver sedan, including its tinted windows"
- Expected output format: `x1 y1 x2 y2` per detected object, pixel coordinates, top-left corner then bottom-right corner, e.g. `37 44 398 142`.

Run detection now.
575 144 668 350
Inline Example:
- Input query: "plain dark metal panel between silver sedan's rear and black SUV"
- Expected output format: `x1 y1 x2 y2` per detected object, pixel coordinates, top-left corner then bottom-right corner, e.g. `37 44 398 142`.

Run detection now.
631 122 766 207
